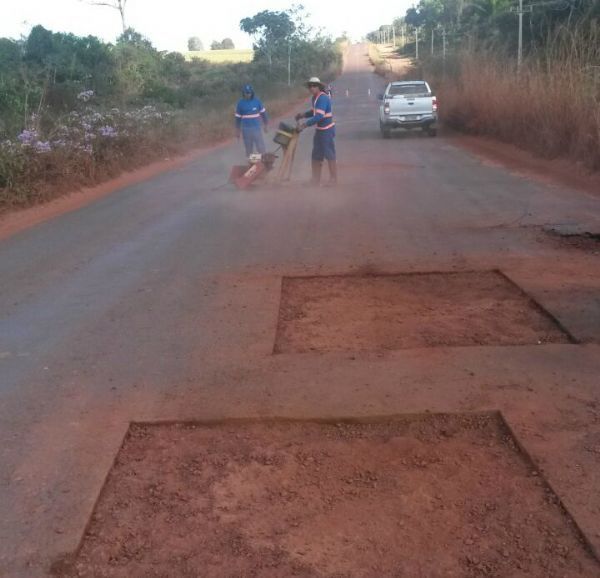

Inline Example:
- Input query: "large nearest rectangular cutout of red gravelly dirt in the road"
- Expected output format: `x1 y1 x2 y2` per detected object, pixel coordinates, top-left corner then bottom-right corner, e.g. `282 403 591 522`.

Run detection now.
54 414 599 578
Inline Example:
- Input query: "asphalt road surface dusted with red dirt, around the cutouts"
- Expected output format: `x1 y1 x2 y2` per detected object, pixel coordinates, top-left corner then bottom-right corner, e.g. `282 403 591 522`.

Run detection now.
0 46 600 577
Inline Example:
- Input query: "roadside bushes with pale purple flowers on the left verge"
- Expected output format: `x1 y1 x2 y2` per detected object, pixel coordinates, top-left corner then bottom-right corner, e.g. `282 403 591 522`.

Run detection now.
0 91 175 208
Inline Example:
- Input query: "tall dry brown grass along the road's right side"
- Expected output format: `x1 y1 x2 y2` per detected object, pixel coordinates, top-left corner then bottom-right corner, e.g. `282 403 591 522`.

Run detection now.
424 27 600 170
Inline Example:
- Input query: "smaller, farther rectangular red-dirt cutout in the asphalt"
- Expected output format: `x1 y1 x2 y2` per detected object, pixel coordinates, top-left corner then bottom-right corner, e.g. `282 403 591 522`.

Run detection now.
274 271 572 353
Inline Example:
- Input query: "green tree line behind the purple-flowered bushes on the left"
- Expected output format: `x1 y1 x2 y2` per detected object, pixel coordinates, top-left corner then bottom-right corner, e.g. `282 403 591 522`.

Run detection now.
0 8 341 137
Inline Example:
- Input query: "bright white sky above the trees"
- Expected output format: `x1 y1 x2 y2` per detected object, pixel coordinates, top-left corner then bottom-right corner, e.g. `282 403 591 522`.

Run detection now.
0 0 412 50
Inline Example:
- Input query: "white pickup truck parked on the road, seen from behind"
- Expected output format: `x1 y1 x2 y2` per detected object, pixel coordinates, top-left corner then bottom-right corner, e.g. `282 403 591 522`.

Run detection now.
379 80 437 138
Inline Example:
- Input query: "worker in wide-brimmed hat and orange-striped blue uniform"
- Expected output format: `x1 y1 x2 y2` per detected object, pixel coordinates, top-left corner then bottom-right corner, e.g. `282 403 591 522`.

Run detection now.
296 77 337 185
